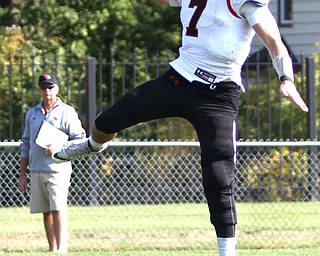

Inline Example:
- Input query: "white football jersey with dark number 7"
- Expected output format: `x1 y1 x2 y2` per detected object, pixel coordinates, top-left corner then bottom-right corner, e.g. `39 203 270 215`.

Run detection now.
170 0 268 87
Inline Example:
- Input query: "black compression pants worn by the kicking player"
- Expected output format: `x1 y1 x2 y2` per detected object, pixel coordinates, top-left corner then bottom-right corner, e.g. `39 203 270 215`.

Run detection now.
95 68 240 237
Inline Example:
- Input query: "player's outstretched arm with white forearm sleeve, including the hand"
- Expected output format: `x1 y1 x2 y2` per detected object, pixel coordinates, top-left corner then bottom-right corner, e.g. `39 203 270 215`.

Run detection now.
244 5 308 112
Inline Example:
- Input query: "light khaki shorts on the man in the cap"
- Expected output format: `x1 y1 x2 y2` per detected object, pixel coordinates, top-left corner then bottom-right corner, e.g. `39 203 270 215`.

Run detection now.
30 171 71 213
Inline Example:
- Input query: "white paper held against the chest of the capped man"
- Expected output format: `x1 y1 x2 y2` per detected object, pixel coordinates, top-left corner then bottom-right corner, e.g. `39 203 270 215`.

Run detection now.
34 120 69 148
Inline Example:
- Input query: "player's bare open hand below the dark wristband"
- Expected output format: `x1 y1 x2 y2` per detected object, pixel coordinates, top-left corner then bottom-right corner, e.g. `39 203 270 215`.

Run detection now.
279 80 309 112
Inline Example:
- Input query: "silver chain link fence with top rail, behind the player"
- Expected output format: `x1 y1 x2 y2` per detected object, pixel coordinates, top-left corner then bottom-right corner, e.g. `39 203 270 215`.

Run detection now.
0 141 320 253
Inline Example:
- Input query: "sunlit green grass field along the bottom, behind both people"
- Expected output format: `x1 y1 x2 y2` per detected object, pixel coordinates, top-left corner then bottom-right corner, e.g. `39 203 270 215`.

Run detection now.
0 203 320 256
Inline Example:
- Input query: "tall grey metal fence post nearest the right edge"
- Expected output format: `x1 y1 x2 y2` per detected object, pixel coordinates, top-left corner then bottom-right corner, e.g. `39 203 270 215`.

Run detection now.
306 57 319 201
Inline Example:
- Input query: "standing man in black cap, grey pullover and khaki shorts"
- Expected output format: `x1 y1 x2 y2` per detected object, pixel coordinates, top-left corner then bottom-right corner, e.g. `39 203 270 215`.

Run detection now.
19 73 85 253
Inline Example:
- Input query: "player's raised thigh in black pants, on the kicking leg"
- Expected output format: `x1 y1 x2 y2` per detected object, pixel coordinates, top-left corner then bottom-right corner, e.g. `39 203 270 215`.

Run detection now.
95 78 179 133
